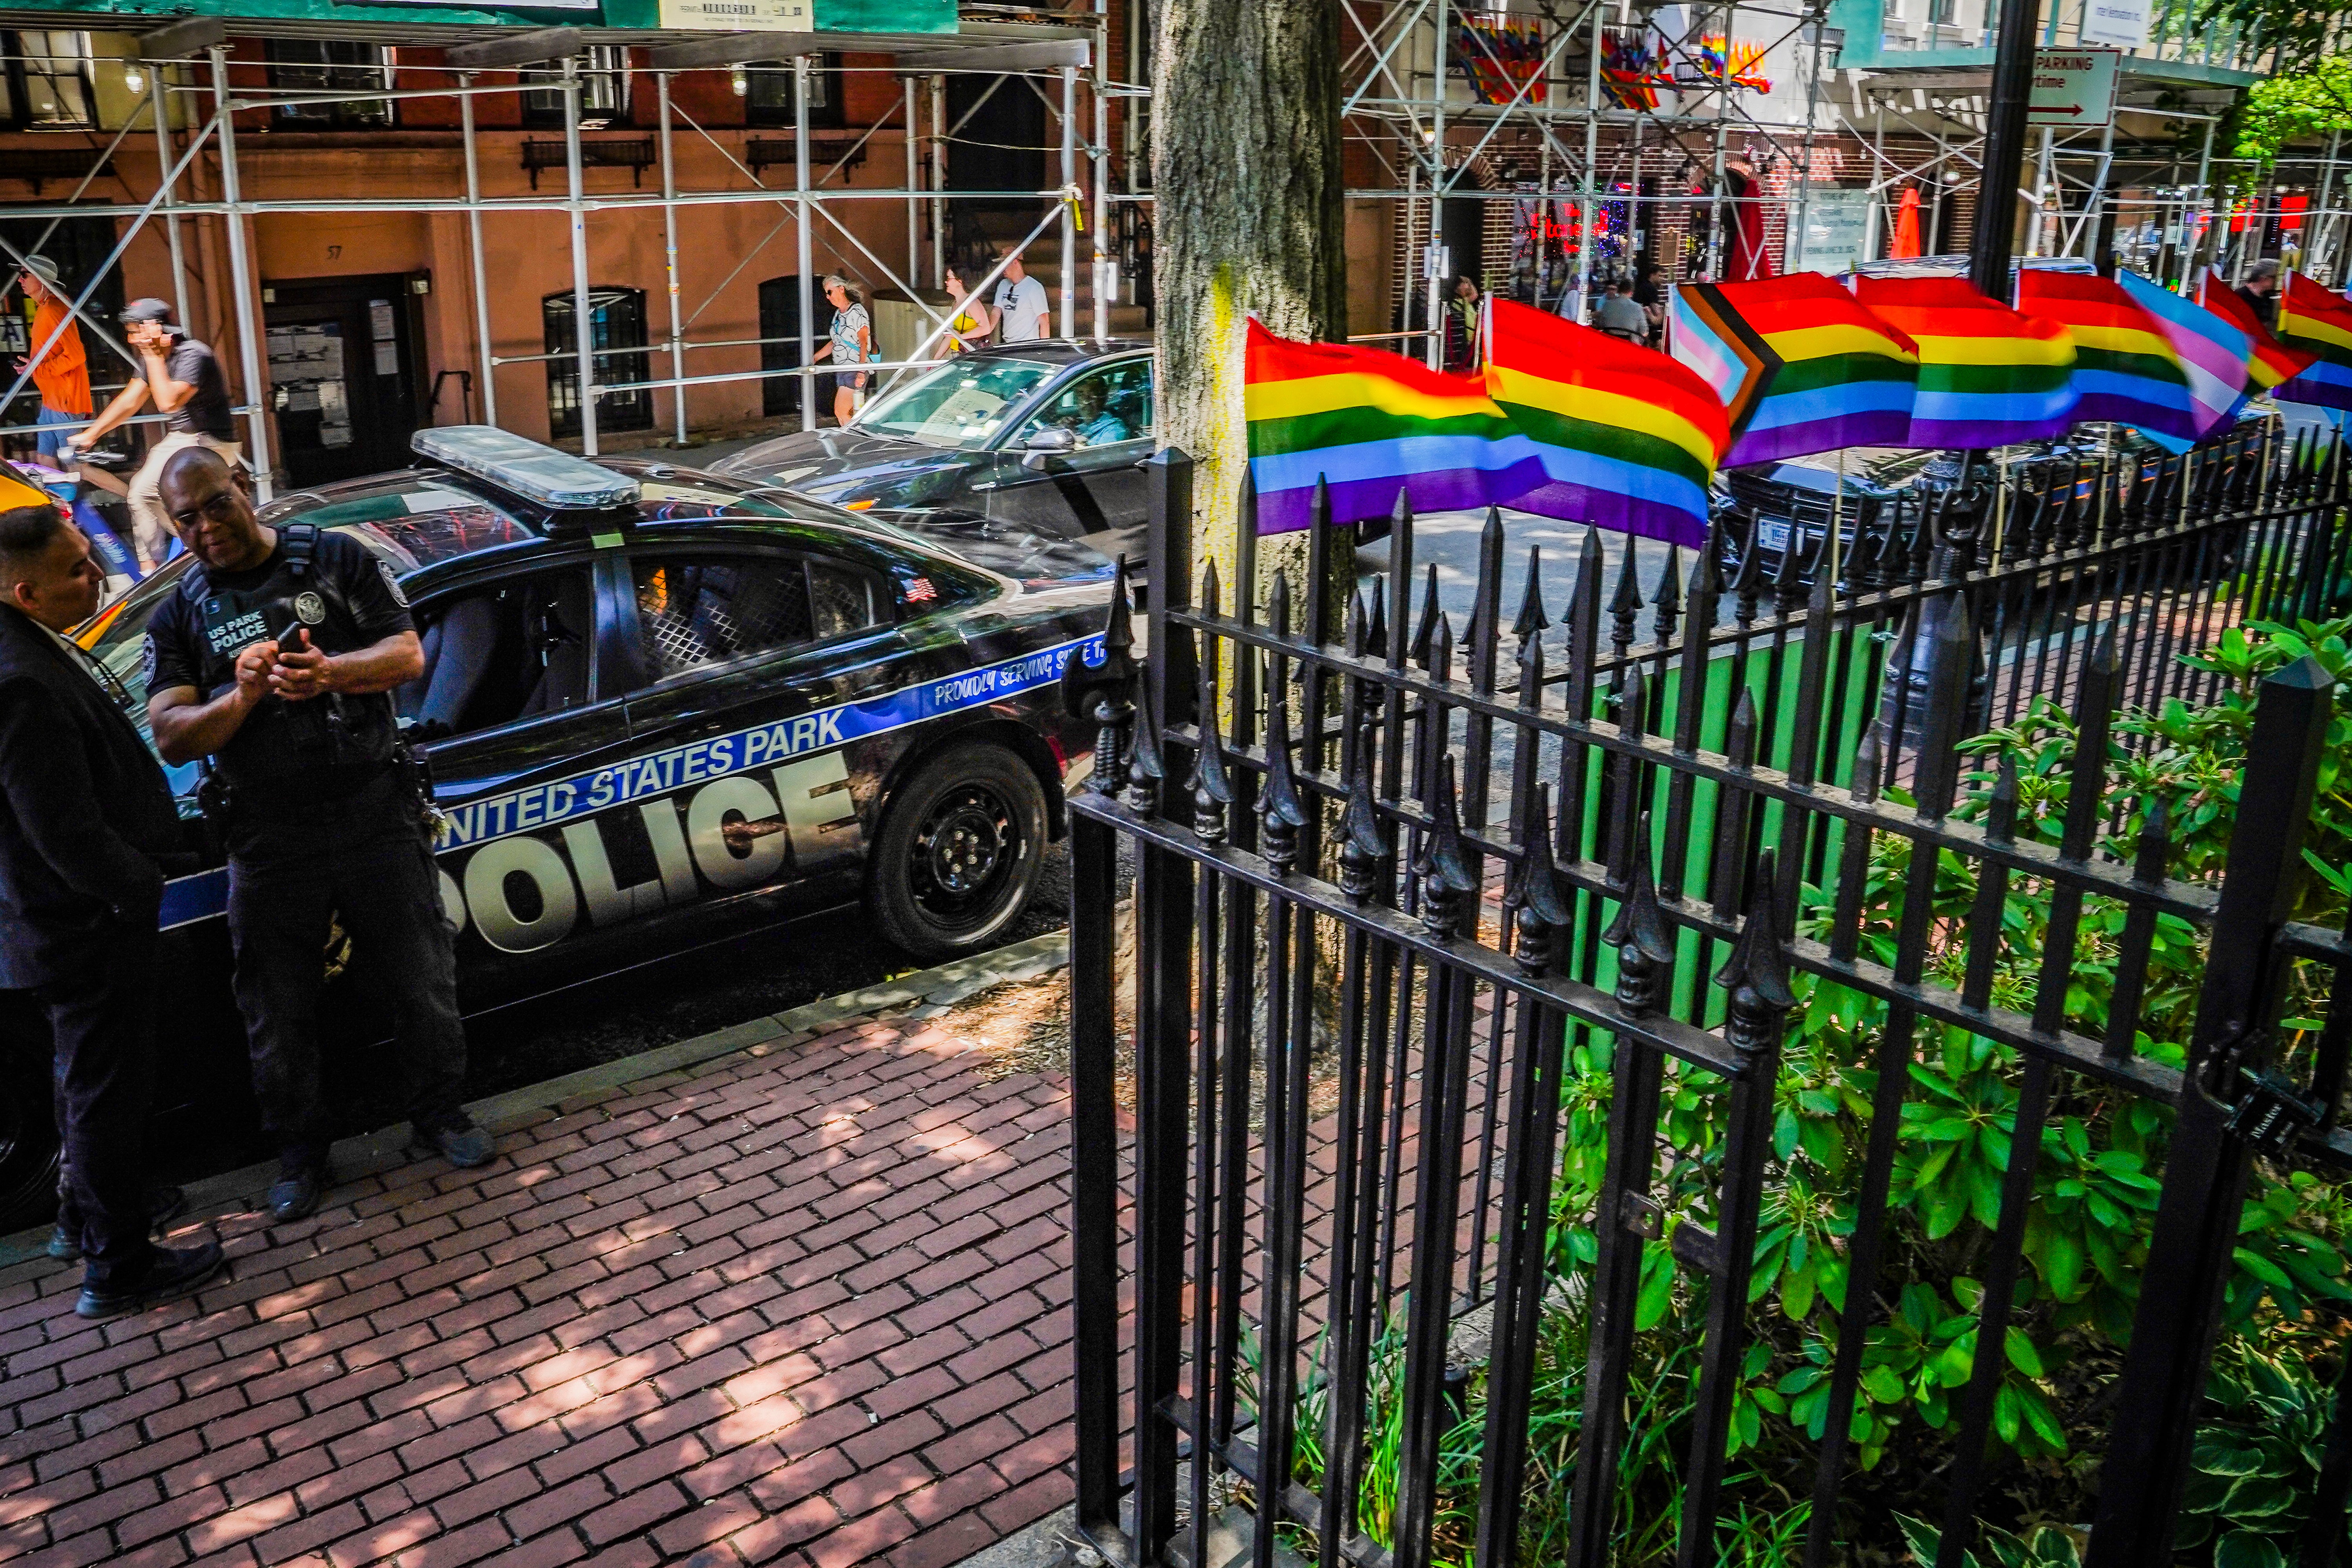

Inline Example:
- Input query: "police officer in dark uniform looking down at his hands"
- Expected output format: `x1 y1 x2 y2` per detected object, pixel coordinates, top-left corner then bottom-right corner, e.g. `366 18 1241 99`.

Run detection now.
148 446 492 1220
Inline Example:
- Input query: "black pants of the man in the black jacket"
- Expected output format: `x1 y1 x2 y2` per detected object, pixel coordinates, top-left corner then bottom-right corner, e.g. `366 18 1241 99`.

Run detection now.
40 919 155 1286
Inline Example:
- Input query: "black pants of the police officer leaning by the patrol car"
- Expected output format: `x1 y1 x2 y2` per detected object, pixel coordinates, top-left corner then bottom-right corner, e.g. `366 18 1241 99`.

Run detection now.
228 773 466 1159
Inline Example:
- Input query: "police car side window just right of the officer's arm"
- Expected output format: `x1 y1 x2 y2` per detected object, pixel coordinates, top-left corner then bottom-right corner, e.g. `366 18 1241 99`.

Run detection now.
393 566 595 740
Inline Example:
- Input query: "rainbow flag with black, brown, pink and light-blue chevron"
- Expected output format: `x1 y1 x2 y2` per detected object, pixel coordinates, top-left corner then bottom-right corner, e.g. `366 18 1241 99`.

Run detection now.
1672 273 1919 468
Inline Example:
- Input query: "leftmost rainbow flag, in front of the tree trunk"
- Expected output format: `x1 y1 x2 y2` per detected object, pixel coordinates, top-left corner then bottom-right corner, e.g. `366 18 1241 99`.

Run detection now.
1242 320 1543 534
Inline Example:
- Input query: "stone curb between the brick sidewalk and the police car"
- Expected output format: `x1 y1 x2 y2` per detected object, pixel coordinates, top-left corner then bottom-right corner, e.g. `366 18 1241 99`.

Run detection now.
0 931 1070 1269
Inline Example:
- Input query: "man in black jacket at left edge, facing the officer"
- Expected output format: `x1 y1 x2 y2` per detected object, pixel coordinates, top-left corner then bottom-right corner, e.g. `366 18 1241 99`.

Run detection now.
0 505 221 1316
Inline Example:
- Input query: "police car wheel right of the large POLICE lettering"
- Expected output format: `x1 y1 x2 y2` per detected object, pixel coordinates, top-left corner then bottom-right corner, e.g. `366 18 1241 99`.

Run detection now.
868 745 1047 959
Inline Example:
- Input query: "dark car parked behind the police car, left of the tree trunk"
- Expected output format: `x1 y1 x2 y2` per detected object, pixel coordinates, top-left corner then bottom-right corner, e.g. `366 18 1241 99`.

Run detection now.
715 339 1152 566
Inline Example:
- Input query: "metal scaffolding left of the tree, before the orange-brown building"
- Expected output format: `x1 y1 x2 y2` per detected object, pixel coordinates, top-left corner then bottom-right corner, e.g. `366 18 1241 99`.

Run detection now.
0 0 1148 498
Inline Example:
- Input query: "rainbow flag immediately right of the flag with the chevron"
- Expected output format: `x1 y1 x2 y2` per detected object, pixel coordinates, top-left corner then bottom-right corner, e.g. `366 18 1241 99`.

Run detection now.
1853 278 2077 446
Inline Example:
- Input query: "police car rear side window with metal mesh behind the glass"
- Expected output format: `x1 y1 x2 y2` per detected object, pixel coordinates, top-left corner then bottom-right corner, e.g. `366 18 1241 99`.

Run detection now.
633 555 877 679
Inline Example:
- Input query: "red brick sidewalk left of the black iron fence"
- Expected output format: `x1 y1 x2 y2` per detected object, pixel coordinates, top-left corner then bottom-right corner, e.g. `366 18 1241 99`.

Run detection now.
0 1016 1091 1568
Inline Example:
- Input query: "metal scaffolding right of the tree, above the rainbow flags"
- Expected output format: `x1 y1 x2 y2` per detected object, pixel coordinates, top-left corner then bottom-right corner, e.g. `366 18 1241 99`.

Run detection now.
1343 0 2305 336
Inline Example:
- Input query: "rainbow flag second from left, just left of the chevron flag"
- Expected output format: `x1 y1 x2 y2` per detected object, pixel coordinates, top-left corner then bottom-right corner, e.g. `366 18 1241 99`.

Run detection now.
1486 299 1731 548
